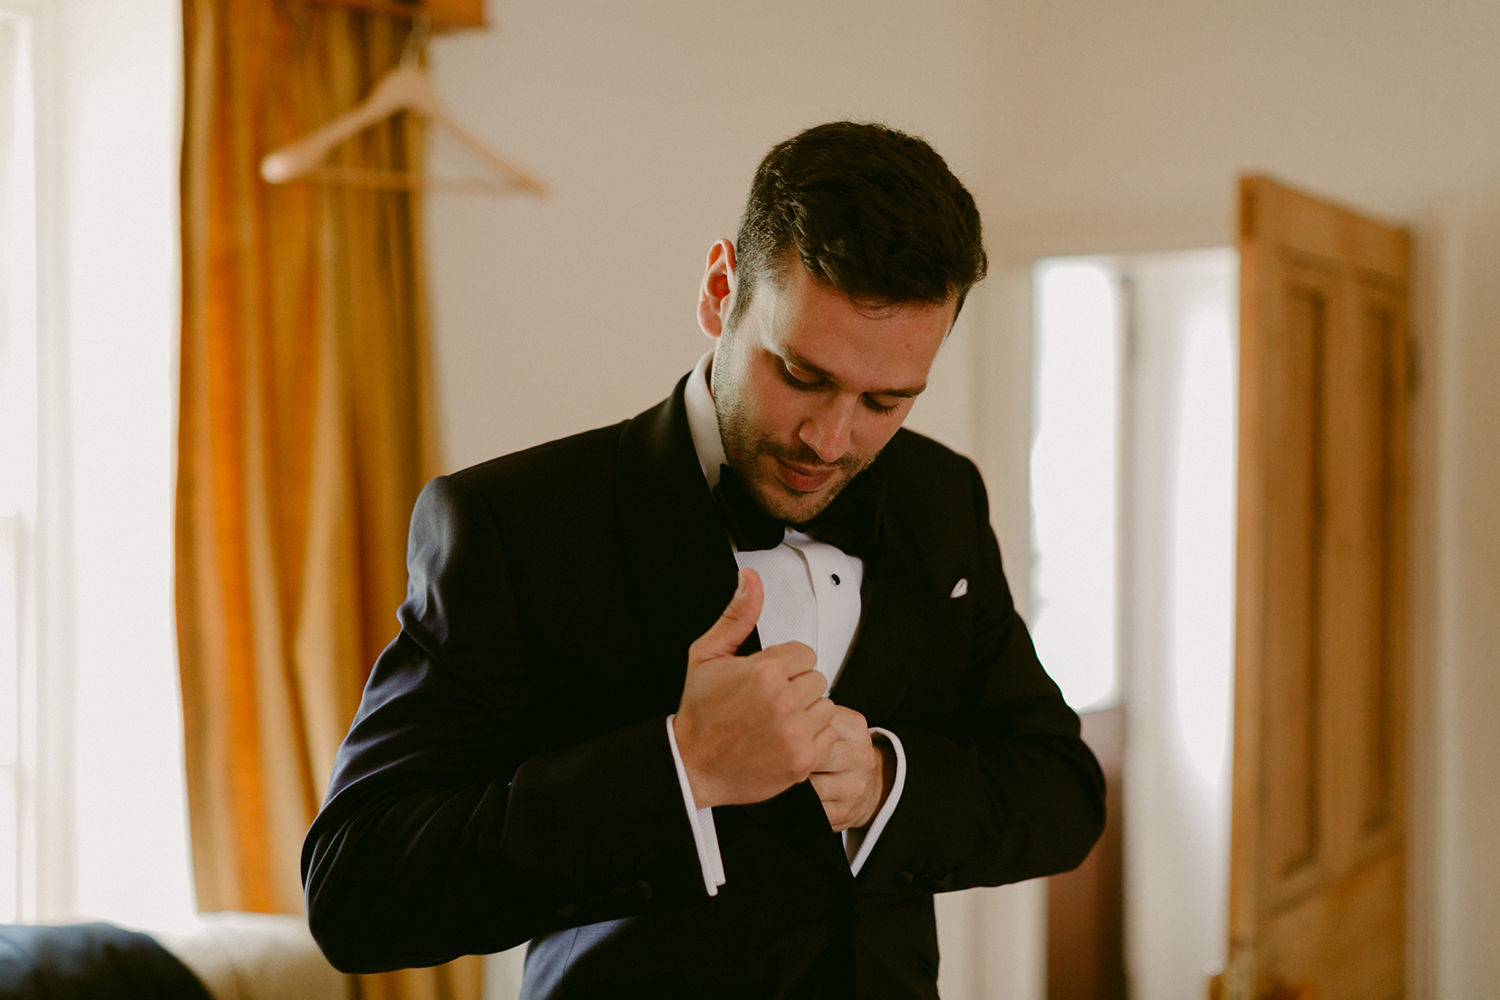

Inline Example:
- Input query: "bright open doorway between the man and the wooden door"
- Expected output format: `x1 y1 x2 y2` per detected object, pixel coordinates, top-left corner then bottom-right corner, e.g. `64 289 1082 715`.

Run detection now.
1031 249 1239 1000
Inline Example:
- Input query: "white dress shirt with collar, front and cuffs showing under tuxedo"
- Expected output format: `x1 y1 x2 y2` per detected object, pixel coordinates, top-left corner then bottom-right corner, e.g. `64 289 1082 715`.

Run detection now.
666 351 906 895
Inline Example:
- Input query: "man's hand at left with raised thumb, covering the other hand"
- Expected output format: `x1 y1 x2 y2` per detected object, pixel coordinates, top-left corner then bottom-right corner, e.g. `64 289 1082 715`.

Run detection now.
672 570 840 808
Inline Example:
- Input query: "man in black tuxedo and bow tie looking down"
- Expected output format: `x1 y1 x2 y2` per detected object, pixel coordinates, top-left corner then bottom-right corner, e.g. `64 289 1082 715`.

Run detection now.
303 123 1104 999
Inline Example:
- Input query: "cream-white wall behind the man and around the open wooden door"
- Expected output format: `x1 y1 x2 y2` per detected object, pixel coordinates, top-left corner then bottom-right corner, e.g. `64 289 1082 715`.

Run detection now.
429 0 1500 999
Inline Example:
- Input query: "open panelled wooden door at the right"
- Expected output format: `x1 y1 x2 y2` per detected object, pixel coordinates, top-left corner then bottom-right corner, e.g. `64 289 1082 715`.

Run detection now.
1218 177 1409 1000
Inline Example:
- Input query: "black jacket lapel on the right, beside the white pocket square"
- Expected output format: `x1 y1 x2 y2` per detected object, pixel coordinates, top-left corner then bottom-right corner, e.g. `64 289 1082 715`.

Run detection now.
830 502 942 726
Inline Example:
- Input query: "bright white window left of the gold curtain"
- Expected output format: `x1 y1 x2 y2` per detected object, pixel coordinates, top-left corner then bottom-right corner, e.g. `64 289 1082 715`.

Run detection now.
0 0 192 928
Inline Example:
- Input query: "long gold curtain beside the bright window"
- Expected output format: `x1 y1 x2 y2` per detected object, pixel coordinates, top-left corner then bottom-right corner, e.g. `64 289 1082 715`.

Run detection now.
177 0 479 1000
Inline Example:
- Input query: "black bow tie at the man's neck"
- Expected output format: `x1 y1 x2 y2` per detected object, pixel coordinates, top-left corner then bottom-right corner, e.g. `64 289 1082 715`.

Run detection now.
714 463 885 559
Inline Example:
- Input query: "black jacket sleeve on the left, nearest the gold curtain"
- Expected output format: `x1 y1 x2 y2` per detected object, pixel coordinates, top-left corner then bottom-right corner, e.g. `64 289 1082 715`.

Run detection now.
302 478 707 973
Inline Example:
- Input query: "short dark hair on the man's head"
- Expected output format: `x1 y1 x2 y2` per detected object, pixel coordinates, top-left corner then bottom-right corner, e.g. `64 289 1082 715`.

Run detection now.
729 121 987 325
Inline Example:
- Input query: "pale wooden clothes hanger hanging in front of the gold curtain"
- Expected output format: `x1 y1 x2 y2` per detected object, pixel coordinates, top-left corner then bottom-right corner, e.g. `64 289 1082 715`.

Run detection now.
261 18 548 196
